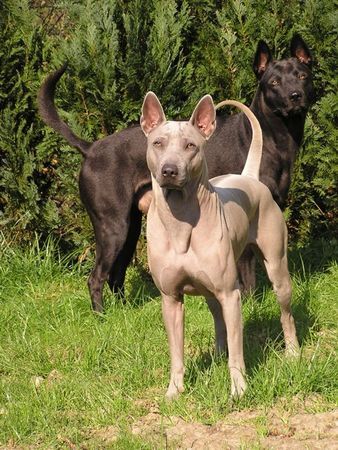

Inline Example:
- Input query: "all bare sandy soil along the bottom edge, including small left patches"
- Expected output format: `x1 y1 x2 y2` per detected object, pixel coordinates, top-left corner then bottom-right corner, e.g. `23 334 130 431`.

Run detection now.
0 398 338 450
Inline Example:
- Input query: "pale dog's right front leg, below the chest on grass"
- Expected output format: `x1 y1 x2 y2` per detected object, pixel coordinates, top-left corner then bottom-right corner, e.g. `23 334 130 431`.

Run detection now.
217 289 246 397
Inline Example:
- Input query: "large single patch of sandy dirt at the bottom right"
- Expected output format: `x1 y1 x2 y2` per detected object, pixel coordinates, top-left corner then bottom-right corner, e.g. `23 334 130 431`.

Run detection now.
132 410 338 450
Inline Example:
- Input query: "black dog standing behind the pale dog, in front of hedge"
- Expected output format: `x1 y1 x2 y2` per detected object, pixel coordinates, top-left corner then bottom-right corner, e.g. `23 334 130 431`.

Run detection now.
38 35 313 311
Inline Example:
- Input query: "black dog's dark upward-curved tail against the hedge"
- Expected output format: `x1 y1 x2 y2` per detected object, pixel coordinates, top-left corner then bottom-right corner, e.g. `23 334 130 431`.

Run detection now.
38 64 91 156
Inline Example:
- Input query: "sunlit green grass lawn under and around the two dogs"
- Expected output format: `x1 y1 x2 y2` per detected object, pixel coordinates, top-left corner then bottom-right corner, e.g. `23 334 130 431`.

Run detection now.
0 234 338 449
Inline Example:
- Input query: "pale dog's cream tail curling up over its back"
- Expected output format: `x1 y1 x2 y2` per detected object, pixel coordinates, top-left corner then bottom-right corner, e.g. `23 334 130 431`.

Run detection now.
216 100 263 180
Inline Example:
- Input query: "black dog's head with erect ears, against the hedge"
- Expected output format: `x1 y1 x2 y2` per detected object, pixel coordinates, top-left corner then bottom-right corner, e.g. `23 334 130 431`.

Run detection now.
253 35 314 118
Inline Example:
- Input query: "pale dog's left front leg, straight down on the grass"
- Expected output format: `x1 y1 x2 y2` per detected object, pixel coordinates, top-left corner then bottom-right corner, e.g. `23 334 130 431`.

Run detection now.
162 294 184 399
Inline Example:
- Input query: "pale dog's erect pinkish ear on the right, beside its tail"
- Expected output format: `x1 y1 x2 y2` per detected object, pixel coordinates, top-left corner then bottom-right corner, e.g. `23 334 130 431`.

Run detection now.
190 95 216 139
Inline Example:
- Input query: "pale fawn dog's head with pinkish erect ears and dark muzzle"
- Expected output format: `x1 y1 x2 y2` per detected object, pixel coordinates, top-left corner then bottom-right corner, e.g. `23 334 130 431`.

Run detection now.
140 92 216 189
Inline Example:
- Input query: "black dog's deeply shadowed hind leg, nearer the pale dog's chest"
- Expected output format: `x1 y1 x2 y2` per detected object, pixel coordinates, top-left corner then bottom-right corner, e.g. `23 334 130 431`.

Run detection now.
108 205 142 298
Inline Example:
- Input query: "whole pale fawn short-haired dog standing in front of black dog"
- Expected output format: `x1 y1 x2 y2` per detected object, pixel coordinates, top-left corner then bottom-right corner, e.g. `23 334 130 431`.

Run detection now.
141 92 299 398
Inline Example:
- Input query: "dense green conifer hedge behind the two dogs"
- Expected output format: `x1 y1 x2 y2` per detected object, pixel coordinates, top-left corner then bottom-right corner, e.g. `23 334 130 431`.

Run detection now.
0 0 338 253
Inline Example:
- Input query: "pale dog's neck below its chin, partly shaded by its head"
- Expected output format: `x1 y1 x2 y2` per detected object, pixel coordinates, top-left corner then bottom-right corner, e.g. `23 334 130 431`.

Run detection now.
153 161 219 254
